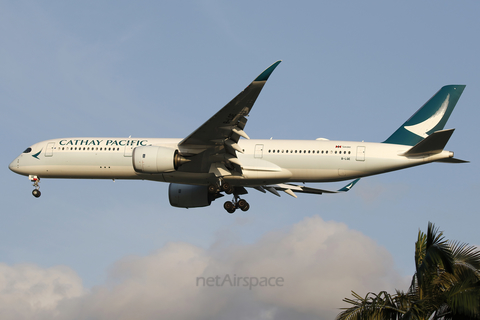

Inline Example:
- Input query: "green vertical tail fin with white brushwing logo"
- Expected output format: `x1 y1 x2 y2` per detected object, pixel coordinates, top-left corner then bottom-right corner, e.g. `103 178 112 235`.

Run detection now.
384 85 465 146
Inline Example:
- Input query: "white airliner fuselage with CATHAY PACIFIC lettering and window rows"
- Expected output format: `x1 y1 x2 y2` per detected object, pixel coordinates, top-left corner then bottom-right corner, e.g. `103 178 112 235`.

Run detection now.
9 138 453 186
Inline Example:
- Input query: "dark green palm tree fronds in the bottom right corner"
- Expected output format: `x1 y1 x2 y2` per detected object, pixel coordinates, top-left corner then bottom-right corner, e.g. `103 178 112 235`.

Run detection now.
337 222 480 320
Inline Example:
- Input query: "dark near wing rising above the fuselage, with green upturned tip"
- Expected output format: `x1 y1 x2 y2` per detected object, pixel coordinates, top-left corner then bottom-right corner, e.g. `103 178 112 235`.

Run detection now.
178 61 281 176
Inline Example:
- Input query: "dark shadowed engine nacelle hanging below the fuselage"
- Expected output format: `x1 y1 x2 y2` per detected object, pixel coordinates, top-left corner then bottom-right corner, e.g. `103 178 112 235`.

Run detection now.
168 183 215 208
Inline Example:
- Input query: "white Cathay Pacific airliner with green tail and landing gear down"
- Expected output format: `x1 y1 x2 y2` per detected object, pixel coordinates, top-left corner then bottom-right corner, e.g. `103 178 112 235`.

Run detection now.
9 60 468 213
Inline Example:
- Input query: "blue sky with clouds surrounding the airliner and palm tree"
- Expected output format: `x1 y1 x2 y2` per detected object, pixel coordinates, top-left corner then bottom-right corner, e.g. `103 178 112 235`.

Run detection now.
0 1 480 319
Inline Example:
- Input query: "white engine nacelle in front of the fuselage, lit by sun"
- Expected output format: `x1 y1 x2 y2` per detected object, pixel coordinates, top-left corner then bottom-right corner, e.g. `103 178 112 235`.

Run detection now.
132 146 188 173
